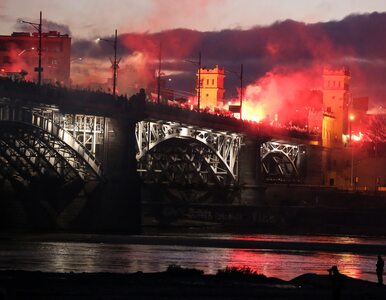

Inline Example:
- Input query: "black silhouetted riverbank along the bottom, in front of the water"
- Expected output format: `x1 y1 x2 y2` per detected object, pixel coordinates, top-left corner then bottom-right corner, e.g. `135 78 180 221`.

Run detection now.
0 271 386 300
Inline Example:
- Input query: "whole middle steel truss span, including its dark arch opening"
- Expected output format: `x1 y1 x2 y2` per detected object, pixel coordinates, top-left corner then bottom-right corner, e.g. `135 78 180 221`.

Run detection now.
135 121 242 186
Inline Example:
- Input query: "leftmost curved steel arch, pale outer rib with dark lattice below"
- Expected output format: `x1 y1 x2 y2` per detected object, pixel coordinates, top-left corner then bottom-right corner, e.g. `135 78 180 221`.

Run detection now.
0 122 98 188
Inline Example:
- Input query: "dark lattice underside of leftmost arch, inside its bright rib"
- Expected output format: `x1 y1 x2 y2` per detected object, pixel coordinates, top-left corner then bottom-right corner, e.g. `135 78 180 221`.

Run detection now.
0 122 82 191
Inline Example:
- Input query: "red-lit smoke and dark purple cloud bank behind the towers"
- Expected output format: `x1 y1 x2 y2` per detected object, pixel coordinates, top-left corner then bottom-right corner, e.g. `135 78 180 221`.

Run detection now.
72 12 386 106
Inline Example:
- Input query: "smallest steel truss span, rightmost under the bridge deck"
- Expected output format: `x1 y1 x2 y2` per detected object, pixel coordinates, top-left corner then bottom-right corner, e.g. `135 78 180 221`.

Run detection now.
260 141 300 181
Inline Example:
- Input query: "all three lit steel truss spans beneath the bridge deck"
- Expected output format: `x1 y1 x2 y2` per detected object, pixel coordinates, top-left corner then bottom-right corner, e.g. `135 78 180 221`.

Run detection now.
0 99 305 190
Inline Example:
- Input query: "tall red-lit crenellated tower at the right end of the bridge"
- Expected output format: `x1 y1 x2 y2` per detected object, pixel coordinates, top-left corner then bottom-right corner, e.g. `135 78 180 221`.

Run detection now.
322 67 351 147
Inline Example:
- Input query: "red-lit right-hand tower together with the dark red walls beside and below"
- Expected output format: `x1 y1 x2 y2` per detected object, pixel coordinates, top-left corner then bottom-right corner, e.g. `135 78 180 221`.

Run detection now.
322 68 386 191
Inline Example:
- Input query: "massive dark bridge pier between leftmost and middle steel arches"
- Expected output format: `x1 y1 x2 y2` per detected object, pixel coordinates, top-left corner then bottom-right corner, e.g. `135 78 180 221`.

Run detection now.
77 118 141 233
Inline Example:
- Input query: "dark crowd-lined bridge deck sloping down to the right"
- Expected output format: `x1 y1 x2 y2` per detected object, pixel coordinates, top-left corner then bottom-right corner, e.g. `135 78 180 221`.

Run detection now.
0 78 318 143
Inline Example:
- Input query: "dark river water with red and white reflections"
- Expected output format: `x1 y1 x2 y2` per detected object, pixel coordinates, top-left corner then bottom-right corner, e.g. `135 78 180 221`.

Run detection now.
0 234 386 282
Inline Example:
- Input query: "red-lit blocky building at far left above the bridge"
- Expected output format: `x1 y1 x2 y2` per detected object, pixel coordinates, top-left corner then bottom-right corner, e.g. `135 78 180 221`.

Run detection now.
0 31 71 84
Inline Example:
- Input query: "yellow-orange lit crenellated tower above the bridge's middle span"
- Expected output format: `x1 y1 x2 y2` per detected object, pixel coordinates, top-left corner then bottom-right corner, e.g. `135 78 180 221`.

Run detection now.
197 65 225 110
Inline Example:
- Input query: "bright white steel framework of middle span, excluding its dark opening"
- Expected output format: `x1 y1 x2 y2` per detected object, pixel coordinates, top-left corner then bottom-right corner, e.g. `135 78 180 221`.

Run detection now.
135 121 242 185
